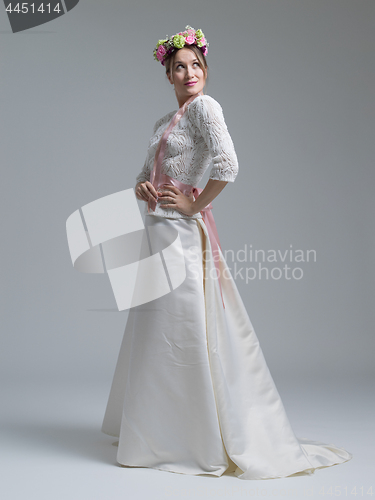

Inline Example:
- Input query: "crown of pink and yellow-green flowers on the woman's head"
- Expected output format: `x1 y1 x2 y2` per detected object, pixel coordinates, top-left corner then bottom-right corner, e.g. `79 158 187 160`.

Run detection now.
154 25 208 66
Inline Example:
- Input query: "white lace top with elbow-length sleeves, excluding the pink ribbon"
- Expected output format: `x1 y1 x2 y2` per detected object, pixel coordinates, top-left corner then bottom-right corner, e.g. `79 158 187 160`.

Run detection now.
136 95 238 218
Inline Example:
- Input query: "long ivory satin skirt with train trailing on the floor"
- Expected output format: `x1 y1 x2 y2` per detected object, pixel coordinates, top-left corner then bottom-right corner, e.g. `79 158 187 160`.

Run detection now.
102 215 352 479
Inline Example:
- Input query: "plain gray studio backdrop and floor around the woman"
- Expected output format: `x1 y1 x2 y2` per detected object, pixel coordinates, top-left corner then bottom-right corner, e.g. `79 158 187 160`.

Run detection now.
0 0 375 500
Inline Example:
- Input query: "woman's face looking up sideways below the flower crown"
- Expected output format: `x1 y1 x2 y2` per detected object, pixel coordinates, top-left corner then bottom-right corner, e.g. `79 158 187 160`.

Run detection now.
167 49 206 101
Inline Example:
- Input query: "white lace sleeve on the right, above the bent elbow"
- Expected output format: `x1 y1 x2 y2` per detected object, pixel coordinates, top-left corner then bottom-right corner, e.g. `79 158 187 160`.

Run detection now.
188 95 238 182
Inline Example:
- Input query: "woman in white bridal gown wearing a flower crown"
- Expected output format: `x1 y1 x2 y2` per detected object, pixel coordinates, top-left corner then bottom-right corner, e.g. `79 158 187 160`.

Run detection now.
102 26 352 479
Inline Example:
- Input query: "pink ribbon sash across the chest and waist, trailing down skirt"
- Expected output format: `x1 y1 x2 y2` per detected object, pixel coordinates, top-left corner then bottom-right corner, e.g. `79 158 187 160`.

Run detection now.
147 91 225 309
